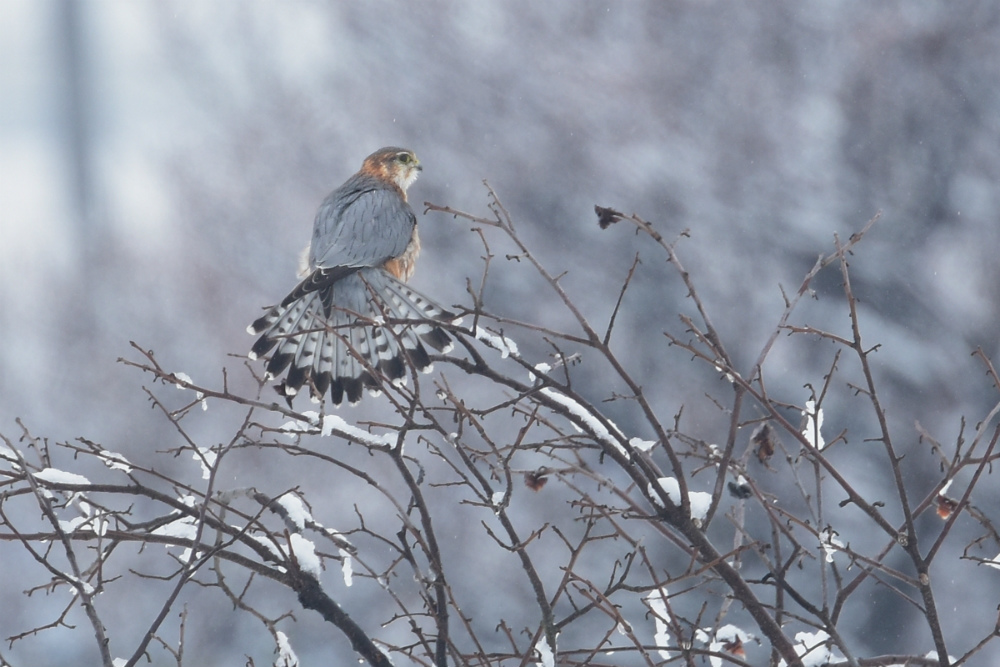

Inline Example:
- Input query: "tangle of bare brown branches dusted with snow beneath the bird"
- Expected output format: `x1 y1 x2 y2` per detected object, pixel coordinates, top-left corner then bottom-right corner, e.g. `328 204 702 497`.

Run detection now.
0 186 1000 667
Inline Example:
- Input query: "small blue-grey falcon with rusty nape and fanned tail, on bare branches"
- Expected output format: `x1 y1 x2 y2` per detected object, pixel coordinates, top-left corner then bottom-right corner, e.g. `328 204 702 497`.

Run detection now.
247 146 460 406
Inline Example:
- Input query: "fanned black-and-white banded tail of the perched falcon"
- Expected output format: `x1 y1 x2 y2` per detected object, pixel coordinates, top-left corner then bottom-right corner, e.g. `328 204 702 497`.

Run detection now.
247 268 457 405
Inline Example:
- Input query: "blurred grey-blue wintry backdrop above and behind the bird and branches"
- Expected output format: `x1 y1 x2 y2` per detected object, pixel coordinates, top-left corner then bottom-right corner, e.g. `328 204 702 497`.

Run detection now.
0 0 1000 664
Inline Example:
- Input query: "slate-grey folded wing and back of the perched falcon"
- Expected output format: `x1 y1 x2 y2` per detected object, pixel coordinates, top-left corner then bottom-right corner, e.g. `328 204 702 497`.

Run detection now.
309 184 417 270
